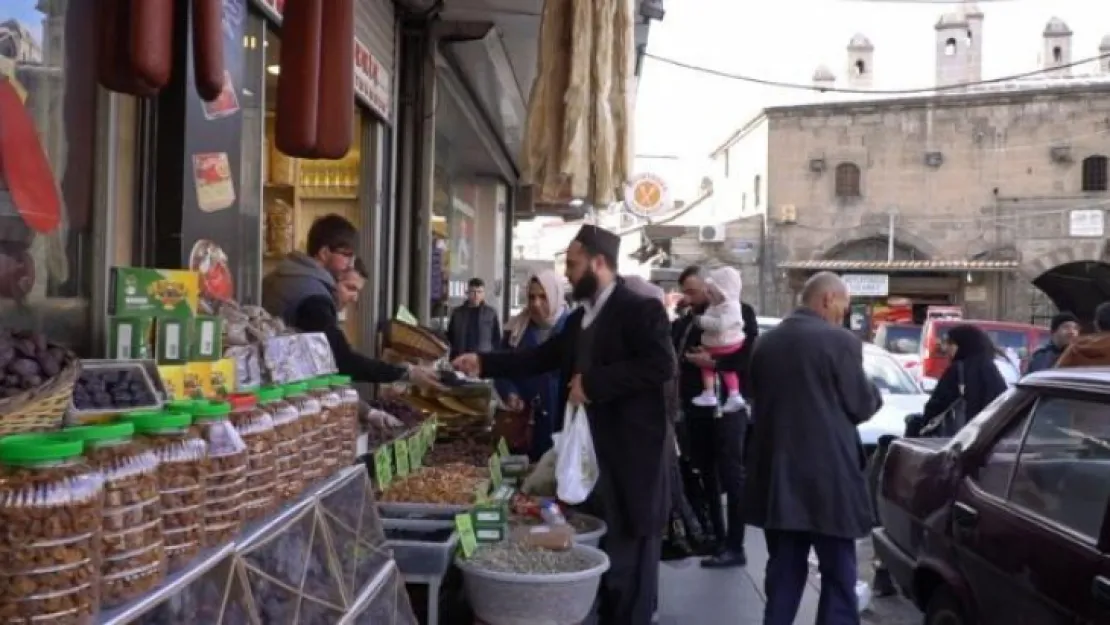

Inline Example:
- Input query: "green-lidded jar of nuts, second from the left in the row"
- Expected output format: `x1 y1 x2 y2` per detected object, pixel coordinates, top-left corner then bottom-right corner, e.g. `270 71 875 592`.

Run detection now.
59 422 167 606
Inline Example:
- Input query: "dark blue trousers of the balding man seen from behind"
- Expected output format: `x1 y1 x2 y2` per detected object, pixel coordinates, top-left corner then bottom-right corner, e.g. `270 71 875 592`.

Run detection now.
764 530 859 625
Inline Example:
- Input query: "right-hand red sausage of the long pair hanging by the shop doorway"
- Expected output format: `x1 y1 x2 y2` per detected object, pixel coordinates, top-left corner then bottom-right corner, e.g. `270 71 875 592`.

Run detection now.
316 0 354 159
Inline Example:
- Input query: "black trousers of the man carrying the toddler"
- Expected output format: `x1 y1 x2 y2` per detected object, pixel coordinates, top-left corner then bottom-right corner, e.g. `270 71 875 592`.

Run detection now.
685 407 748 553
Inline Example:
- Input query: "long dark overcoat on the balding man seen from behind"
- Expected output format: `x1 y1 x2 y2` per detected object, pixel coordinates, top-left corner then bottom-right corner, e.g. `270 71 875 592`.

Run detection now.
745 309 882 538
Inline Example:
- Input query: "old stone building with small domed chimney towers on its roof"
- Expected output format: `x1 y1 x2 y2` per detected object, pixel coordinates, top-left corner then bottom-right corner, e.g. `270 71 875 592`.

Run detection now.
646 6 1110 322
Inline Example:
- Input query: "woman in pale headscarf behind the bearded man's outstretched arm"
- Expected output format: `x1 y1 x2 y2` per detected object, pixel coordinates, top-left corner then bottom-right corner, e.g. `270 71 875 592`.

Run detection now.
495 269 567 462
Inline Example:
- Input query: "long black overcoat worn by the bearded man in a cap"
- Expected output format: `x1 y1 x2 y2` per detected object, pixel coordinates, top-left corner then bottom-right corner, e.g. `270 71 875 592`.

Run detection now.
481 282 675 536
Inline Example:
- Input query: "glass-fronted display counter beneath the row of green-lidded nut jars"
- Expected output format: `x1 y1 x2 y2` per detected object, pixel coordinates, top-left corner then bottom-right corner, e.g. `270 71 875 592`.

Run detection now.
99 465 416 625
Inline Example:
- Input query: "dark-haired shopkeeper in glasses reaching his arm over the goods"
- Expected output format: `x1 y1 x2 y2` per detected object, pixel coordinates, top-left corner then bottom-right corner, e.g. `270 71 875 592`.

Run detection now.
262 214 440 389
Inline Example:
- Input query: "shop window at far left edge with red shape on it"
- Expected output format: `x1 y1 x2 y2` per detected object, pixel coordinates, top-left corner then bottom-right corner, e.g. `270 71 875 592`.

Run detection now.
0 0 99 354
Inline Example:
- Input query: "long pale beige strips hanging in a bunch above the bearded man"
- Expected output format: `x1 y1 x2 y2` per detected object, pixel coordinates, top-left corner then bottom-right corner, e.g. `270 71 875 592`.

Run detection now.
521 0 636 206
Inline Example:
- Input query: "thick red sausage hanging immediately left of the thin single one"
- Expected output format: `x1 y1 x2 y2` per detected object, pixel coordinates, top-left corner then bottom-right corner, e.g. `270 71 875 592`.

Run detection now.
124 0 175 90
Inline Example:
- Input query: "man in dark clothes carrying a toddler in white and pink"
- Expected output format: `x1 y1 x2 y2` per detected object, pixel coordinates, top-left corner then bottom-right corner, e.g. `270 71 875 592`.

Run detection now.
672 266 759 568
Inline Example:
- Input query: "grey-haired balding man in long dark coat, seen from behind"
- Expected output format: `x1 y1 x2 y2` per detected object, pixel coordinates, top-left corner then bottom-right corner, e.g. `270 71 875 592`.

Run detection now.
745 272 882 625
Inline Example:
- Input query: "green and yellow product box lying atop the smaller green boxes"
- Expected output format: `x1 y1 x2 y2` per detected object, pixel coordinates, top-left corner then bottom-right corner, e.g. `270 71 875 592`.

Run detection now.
109 266 200 319
